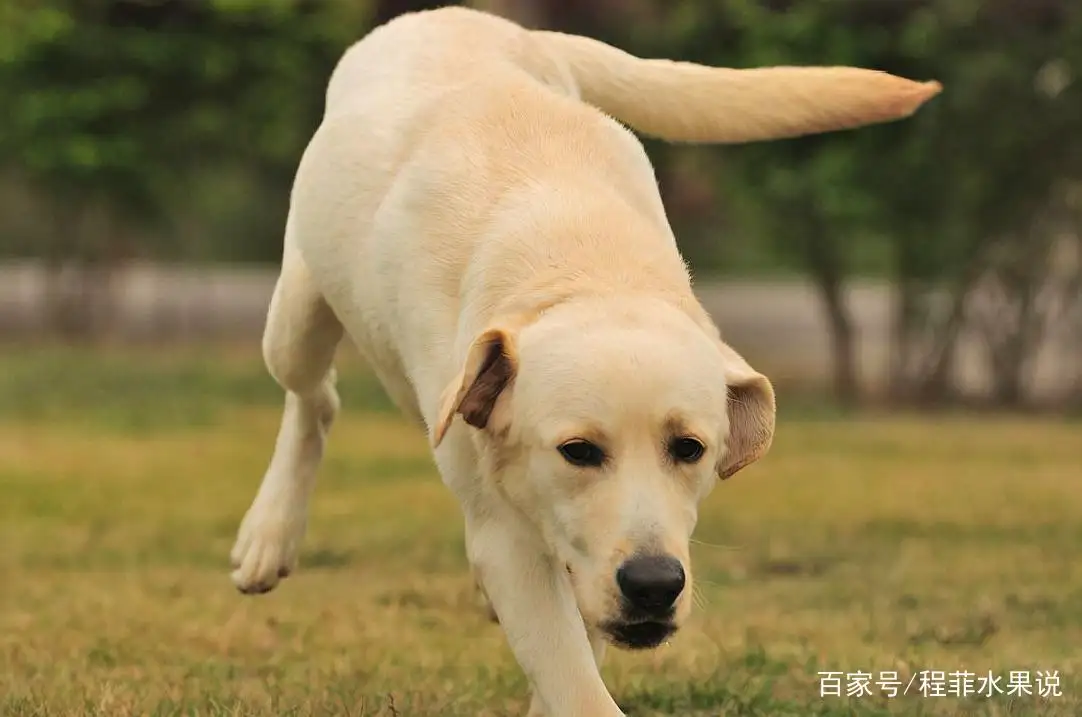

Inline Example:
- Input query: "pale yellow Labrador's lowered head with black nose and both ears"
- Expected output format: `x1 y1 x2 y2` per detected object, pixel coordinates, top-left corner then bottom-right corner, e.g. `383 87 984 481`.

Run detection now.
434 300 775 649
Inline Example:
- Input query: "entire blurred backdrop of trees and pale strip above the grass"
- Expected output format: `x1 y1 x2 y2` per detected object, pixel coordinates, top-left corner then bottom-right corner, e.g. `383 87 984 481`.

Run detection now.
0 0 1082 410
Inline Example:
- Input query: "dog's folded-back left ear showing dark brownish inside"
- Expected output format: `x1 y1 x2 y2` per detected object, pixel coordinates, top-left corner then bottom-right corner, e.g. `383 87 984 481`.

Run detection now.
432 328 518 448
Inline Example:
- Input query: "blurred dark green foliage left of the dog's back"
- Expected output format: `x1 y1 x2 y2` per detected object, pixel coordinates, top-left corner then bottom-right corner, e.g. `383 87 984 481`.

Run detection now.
0 0 371 337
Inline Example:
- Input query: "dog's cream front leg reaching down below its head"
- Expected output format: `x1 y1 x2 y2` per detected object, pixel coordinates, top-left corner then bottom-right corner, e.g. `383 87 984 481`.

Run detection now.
467 515 623 717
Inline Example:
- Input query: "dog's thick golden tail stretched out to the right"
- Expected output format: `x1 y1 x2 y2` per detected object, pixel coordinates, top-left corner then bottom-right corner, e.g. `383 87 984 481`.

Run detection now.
535 30 942 144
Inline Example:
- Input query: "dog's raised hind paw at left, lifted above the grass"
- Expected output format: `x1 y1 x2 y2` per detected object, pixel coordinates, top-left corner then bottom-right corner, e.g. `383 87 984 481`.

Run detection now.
229 503 305 595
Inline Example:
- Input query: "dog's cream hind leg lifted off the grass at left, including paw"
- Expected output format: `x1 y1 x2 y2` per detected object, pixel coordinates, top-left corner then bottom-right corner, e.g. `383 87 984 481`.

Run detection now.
230 244 343 595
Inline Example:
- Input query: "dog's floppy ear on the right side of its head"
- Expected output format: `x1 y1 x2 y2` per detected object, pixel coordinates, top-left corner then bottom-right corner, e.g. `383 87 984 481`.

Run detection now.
717 342 775 480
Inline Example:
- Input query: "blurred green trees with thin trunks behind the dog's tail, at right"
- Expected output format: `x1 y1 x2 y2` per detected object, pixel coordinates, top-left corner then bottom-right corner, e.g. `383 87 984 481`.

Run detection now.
637 0 1082 402
